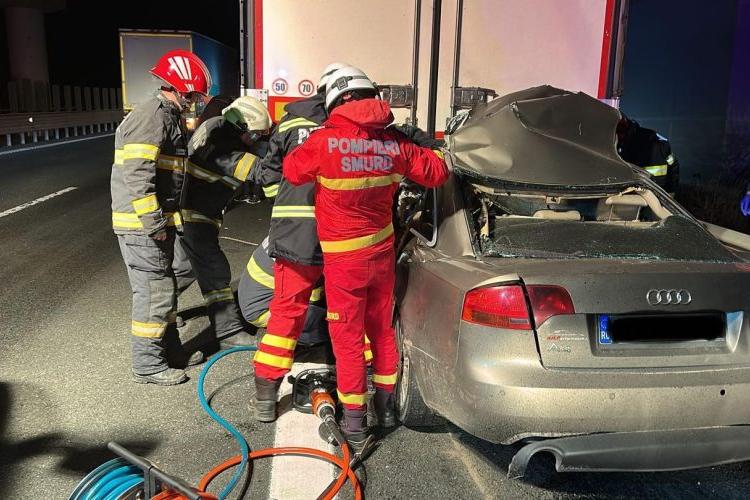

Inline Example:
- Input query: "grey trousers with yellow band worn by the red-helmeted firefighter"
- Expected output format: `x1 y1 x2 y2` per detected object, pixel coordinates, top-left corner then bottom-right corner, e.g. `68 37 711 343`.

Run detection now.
117 229 195 375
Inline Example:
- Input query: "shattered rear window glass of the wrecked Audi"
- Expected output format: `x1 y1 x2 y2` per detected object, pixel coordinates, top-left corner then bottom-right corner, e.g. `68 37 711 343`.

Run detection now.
482 215 739 263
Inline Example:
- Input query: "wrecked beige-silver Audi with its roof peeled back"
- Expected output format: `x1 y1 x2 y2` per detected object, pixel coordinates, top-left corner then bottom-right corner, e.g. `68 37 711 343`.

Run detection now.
396 87 750 476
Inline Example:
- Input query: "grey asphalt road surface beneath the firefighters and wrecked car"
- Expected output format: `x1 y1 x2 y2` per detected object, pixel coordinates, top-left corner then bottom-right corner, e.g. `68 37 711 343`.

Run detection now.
0 136 750 499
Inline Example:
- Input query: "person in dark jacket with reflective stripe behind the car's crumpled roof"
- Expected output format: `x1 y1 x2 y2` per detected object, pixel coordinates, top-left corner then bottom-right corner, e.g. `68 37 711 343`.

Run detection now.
617 113 680 196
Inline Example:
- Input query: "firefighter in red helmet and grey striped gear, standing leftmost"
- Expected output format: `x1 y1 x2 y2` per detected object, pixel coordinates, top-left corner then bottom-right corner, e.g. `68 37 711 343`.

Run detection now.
111 50 211 385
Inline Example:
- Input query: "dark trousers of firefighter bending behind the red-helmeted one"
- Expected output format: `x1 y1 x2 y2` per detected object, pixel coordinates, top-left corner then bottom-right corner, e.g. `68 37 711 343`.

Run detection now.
181 222 244 340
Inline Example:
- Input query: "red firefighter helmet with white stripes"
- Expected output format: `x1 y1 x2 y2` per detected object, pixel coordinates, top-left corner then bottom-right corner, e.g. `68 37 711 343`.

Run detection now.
151 50 211 95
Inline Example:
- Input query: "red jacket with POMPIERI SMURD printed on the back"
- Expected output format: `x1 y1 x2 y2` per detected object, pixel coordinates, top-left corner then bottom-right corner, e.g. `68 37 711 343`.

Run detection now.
284 99 449 259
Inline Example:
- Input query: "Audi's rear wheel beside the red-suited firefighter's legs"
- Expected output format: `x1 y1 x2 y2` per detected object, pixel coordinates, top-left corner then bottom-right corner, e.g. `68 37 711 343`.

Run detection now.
395 320 445 428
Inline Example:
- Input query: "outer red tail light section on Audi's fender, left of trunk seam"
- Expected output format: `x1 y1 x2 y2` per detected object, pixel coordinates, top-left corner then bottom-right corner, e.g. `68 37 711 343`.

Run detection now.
461 285 531 330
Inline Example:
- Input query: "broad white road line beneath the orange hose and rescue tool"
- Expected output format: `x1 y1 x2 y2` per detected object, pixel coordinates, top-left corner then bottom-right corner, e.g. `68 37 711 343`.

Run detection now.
268 363 337 500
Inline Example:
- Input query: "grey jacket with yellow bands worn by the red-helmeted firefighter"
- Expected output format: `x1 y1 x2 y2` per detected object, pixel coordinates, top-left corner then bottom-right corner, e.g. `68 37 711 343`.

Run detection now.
110 94 187 235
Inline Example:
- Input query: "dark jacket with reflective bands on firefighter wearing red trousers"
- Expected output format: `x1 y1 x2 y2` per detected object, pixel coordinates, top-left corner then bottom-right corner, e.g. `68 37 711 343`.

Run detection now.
256 94 326 265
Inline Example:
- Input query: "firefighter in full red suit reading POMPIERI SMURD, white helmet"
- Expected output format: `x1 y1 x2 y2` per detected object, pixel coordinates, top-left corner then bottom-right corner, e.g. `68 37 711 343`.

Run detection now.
280 67 449 451
